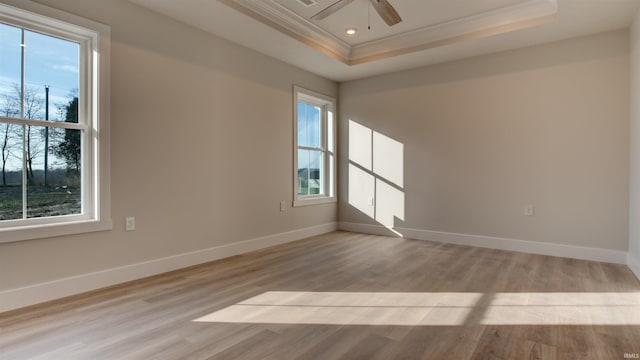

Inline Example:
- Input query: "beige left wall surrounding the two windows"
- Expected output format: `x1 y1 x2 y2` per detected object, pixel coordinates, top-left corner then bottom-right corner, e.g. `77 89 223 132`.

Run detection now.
0 0 337 290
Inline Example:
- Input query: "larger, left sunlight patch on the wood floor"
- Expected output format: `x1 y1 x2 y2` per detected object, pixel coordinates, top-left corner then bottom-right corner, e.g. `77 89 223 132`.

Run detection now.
195 291 482 326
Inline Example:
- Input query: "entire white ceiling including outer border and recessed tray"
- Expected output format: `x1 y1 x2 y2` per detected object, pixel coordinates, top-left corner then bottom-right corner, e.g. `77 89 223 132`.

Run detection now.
130 0 640 81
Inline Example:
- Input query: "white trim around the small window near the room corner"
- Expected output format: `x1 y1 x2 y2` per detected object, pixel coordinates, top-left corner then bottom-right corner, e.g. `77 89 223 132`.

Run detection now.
293 85 338 207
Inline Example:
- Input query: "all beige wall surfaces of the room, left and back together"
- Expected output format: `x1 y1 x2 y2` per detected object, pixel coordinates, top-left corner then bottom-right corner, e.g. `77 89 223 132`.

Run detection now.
0 0 640 306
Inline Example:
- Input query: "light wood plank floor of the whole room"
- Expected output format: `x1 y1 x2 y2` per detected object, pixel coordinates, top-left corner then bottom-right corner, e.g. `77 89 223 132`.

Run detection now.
0 232 640 360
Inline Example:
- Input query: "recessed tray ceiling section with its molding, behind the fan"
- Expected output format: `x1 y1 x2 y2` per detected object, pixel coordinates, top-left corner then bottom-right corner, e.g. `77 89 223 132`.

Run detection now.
219 0 558 65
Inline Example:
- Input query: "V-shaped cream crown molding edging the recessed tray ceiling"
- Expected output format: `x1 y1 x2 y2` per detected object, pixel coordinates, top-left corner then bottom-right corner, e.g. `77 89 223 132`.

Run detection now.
218 0 558 65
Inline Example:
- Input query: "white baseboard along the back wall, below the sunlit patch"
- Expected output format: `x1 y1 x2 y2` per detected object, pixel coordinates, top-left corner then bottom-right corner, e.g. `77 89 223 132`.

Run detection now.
339 222 638 264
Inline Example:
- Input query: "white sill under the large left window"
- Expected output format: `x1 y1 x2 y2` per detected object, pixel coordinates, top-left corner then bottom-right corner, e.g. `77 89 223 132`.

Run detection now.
0 220 113 243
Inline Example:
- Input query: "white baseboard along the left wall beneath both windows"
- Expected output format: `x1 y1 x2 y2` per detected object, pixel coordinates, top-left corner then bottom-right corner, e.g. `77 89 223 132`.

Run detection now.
0 222 338 312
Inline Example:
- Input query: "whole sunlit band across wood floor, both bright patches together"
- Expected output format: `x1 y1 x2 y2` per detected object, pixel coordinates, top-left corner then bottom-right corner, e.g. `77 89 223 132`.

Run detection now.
194 291 640 326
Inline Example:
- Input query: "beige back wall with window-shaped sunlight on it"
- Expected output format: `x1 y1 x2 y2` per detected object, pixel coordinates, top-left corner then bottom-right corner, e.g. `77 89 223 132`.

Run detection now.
339 31 629 251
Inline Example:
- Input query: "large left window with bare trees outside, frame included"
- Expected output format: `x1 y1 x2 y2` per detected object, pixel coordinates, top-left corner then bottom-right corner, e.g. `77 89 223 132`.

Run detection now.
0 2 111 242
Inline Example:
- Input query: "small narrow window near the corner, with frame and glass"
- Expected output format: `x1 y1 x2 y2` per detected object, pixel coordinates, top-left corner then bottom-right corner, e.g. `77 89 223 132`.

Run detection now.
294 86 336 206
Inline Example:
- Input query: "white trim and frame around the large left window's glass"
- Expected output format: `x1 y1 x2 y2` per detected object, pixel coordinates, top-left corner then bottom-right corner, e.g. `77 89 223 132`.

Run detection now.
0 0 112 243
